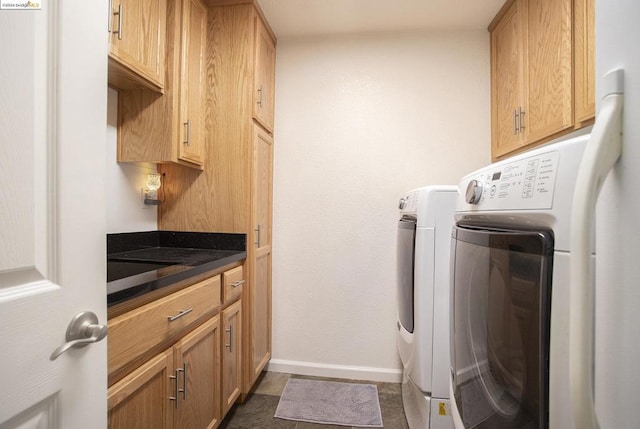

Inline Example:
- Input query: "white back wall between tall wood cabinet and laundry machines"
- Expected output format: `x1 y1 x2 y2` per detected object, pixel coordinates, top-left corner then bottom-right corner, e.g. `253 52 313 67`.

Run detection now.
269 30 490 381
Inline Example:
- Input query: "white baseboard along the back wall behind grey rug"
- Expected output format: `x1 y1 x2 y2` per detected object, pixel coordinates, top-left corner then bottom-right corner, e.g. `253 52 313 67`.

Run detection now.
265 359 402 383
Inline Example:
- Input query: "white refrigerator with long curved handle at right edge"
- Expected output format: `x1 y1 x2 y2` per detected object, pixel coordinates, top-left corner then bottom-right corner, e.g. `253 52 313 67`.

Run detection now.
571 0 640 429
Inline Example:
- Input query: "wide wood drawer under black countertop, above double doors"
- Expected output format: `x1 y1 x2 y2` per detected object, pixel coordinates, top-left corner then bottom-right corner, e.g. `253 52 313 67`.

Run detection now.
107 276 221 375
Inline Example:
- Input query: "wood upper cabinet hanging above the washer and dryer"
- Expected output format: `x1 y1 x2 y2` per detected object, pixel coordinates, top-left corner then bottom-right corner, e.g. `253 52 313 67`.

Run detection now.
489 0 593 160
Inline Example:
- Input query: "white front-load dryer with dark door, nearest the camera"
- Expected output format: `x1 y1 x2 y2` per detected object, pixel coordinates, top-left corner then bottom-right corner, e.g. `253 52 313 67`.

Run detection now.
450 134 589 429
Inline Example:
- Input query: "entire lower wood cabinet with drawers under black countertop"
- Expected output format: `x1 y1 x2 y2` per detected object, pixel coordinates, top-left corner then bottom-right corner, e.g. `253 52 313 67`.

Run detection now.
108 266 243 429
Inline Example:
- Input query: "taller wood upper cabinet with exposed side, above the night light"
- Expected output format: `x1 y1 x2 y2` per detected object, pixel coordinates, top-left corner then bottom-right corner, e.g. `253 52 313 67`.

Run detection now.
118 0 207 170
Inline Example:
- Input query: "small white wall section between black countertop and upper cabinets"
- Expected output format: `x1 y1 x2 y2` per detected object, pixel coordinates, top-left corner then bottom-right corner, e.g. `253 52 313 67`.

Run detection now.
106 88 158 234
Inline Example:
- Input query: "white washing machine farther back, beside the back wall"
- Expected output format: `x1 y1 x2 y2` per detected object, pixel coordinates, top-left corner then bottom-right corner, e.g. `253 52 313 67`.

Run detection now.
396 186 458 429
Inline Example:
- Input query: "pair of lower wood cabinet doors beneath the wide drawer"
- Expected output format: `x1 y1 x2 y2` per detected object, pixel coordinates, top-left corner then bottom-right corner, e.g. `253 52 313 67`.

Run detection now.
108 316 222 429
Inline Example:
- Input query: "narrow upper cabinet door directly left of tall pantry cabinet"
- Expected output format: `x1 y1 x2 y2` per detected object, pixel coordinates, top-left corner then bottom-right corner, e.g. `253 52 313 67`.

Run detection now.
178 0 207 165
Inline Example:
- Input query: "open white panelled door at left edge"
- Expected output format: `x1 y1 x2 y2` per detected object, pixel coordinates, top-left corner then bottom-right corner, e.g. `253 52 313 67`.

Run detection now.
0 0 108 429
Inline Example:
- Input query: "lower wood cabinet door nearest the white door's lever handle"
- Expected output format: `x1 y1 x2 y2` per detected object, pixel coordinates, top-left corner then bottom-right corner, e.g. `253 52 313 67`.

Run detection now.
107 350 177 429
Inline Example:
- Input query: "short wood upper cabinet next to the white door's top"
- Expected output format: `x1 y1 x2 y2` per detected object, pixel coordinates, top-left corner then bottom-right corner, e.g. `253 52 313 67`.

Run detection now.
109 0 167 93
